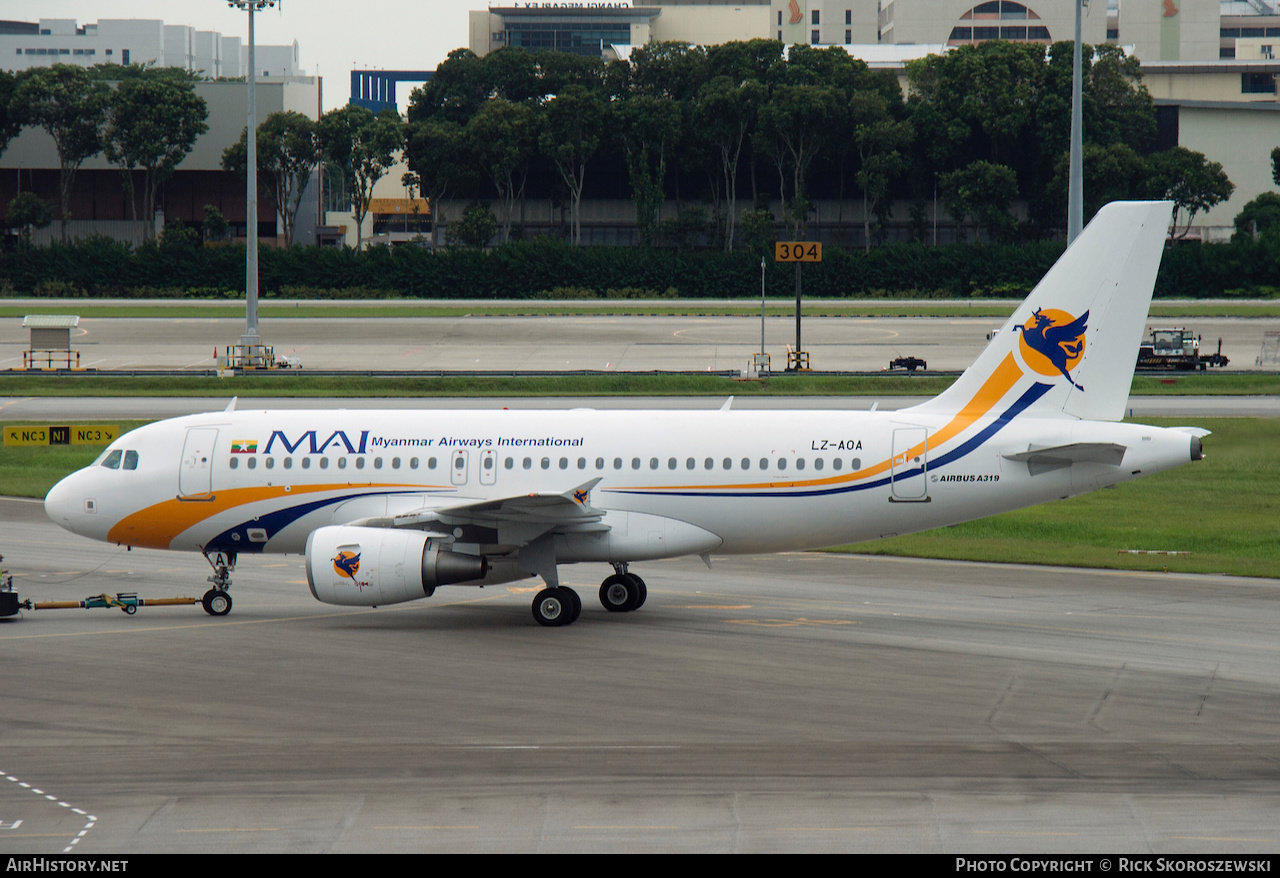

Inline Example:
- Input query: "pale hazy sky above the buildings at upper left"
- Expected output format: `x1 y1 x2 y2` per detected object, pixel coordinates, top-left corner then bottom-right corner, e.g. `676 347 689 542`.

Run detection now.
13 0 476 111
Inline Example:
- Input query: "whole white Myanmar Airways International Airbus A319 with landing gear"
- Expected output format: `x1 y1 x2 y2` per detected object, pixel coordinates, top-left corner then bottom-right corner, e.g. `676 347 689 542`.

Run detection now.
45 202 1207 626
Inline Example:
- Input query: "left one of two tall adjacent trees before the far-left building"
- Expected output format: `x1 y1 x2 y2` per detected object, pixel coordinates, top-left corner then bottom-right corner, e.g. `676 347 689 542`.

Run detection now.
12 64 108 242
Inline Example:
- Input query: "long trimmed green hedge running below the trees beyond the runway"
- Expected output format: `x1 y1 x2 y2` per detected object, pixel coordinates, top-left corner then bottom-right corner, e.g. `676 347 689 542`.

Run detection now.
0 238 1280 299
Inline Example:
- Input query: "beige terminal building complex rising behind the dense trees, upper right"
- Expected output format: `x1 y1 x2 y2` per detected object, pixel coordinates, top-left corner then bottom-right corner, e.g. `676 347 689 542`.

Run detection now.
468 0 1280 239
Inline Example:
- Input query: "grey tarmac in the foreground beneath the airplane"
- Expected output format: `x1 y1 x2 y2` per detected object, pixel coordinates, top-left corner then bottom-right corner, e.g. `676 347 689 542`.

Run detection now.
0 499 1280 856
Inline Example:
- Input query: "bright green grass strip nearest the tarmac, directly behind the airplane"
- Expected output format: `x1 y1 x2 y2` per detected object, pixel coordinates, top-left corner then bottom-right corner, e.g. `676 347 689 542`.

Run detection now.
0 419 1280 577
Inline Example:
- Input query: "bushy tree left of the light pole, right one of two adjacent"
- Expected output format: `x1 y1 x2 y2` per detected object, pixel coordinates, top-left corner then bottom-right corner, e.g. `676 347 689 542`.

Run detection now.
102 67 209 238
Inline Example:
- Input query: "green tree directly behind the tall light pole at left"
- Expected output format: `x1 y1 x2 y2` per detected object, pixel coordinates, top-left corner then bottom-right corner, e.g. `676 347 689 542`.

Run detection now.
223 110 320 247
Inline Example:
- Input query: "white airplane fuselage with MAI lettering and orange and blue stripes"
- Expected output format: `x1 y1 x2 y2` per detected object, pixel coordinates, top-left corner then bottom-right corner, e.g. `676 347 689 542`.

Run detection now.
46 410 1192 563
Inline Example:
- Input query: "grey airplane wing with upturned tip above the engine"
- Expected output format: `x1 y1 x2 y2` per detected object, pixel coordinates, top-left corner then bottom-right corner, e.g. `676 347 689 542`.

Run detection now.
352 479 609 545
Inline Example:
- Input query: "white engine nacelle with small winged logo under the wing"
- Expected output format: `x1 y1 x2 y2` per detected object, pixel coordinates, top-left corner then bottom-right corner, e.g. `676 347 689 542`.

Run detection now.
306 526 489 607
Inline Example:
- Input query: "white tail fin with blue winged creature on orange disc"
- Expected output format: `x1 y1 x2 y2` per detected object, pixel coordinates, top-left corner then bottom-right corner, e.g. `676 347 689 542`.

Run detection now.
913 201 1172 421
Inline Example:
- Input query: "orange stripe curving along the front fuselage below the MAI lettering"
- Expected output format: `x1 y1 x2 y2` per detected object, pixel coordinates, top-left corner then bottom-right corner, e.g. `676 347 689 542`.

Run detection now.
106 483 439 549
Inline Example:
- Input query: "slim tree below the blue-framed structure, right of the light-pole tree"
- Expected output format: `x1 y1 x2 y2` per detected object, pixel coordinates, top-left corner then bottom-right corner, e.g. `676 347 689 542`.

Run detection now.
317 104 404 250
